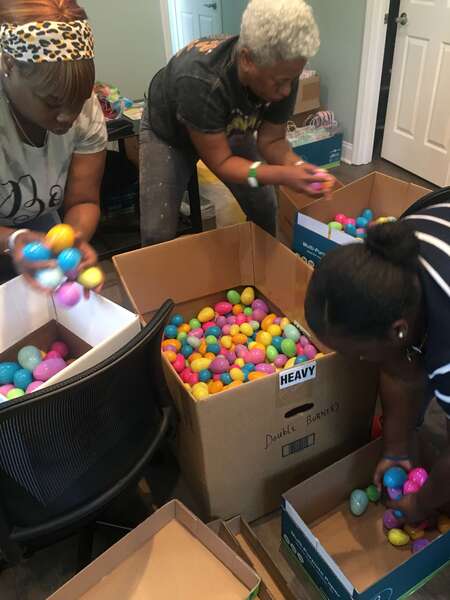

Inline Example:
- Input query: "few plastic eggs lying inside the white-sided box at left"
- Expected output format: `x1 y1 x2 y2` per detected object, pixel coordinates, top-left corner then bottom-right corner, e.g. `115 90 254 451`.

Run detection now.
0 341 72 401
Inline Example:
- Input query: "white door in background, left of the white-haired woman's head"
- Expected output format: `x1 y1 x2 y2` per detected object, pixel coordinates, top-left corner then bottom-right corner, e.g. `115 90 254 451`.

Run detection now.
174 0 222 50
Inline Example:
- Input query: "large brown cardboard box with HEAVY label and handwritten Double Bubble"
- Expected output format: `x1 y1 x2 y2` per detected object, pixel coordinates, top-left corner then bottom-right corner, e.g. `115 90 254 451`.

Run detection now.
114 223 377 520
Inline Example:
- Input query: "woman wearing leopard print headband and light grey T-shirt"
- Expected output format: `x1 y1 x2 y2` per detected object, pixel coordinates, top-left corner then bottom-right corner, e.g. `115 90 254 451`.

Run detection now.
0 0 107 287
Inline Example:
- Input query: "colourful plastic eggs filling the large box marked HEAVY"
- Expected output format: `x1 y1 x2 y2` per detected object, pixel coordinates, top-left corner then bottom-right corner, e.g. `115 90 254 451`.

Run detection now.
162 287 321 400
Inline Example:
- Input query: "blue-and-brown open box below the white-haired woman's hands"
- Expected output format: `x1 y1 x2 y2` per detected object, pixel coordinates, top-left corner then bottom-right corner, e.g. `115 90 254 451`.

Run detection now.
293 172 430 266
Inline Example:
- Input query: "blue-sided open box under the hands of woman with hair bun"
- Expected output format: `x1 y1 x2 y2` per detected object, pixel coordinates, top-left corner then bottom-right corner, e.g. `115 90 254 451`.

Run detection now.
282 440 450 600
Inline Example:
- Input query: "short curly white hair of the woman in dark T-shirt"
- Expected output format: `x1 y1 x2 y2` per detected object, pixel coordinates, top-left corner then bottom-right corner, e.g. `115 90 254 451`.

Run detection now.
239 0 320 66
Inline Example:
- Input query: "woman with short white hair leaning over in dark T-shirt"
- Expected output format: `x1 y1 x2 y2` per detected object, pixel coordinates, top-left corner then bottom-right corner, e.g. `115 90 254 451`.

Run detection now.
140 0 334 245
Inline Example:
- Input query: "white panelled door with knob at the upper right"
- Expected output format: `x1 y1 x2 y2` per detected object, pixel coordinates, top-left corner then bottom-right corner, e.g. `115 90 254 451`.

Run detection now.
381 0 450 186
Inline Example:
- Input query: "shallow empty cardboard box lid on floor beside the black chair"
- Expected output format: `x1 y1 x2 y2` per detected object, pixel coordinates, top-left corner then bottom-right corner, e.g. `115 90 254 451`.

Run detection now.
49 500 260 600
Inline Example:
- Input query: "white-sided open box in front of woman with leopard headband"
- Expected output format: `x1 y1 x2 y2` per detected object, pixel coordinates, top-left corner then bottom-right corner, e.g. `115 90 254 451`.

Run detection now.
0 277 141 401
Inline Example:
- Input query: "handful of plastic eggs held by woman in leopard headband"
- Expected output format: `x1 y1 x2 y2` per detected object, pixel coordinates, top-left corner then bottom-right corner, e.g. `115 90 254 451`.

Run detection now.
23 224 104 308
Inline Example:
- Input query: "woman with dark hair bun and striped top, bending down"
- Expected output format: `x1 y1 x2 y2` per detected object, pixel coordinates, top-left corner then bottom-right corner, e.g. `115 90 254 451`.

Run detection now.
305 198 450 523
